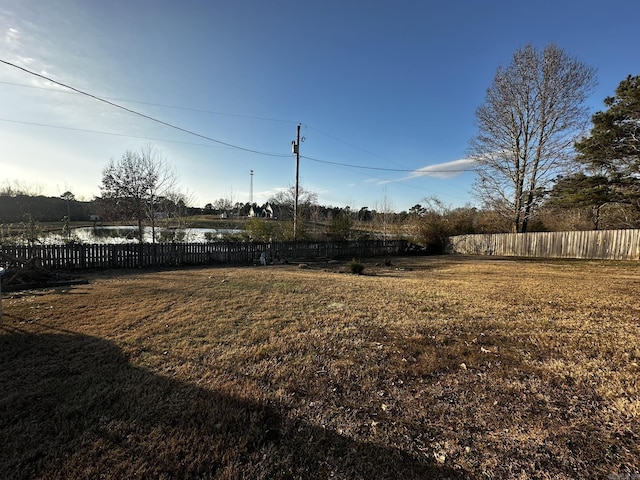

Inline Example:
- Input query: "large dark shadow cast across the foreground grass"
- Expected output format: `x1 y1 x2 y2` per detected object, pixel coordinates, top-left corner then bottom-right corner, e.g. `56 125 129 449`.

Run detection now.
0 327 463 479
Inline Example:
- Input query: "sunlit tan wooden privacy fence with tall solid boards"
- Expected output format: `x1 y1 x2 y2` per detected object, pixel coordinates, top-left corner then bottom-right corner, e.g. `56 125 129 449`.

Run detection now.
447 230 640 260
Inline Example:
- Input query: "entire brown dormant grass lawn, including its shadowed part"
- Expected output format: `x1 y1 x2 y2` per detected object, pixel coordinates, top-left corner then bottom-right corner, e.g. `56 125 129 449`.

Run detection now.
0 257 640 479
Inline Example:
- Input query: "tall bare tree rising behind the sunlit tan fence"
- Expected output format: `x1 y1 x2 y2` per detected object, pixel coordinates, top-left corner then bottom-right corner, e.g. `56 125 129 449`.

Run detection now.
470 45 595 232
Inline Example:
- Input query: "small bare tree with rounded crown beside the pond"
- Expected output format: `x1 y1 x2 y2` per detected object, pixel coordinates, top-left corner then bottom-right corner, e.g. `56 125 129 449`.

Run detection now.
101 145 178 243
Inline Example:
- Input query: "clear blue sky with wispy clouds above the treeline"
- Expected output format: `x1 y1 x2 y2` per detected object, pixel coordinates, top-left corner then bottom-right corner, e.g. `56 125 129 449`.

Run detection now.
0 0 640 211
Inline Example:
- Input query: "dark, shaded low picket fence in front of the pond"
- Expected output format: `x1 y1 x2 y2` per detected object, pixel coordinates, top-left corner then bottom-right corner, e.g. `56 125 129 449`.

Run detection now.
0 240 407 270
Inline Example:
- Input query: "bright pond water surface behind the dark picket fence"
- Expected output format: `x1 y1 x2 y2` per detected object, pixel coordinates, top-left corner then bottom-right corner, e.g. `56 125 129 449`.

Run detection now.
45 226 244 244
